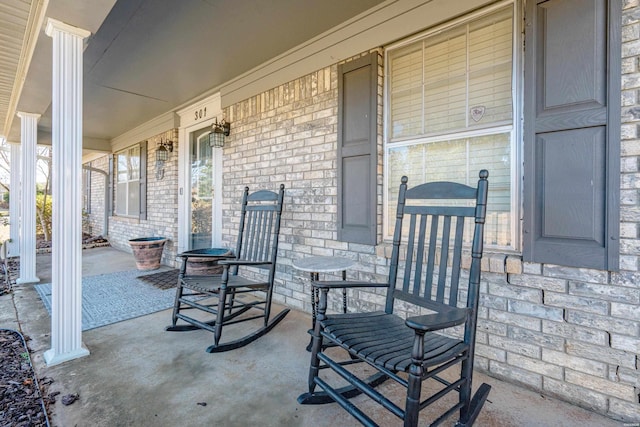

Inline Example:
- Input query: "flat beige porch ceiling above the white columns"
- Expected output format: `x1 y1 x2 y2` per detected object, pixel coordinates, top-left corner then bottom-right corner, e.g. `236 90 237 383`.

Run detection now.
0 0 382 147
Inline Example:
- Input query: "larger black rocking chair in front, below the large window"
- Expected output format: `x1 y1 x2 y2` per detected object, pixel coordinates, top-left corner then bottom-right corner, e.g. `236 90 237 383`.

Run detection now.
298 170 491 426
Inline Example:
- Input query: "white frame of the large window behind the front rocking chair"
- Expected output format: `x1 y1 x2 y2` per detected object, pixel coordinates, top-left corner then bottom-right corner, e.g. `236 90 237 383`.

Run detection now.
382 0 524 253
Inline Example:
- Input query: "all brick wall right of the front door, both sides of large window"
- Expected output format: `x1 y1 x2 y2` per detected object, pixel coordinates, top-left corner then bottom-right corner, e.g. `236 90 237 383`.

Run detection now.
223 33 640 422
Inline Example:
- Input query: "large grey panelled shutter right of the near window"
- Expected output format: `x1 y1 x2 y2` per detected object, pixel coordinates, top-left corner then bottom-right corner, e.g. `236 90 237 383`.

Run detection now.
523 0 621 270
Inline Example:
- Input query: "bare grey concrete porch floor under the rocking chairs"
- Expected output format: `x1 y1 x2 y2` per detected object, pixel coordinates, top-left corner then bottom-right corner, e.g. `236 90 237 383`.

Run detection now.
0 248 623 427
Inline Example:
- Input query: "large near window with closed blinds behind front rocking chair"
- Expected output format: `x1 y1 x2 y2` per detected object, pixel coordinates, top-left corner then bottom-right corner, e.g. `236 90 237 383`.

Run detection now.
385 3 517 248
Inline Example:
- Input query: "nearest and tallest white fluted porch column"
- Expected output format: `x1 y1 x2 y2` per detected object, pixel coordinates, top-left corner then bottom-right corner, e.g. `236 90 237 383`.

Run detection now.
44 18 91 366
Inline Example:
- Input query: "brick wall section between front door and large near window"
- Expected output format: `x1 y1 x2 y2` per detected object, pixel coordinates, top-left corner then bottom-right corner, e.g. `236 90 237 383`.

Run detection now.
223 51 385 318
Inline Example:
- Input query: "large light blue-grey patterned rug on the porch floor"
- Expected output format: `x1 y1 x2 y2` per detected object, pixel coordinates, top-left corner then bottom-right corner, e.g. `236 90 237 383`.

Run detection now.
34 270 184 331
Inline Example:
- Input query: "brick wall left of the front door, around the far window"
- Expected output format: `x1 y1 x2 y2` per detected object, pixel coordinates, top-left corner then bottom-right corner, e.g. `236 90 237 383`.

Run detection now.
85 129 178 266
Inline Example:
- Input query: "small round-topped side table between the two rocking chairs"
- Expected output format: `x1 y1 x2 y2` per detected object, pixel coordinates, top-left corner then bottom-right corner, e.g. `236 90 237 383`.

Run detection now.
293 256 355 350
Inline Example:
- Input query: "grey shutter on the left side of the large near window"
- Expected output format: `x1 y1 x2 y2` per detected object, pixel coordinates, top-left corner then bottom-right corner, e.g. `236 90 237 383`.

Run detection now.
338 53 378 245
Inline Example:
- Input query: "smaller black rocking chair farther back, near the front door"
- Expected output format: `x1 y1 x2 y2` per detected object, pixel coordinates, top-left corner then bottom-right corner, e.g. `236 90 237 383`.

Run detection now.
166 185 289 353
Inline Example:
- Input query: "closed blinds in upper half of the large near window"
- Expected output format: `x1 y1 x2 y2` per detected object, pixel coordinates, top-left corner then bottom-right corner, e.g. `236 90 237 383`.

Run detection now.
389 8 513 141
